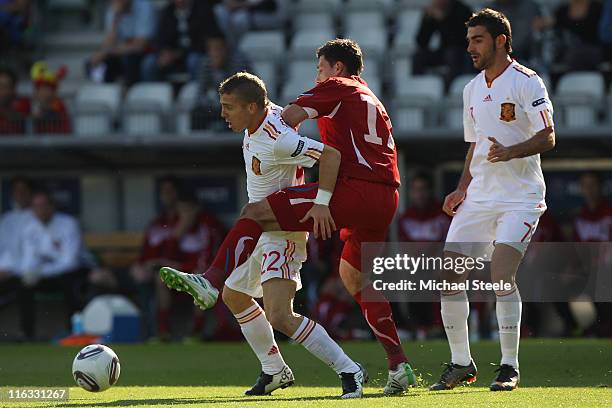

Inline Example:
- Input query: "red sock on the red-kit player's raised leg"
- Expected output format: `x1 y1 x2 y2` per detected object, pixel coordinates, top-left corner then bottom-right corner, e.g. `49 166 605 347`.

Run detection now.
204 218 263 291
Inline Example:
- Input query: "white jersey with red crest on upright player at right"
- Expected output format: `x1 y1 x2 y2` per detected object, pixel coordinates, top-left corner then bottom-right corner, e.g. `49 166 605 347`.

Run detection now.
463 61 553 204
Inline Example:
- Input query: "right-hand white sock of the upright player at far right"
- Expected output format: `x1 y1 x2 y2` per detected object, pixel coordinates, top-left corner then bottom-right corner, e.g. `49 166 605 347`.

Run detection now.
495 288 523 368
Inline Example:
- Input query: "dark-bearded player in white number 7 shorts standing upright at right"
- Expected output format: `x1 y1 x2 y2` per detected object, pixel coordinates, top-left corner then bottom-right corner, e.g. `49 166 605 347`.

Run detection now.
431 9 555 391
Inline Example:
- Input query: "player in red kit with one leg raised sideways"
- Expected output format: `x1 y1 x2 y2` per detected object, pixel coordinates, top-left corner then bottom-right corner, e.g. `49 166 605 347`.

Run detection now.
162 39 416 394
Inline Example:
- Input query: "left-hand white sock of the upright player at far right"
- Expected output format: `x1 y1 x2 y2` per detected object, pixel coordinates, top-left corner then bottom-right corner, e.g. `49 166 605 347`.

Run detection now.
440 291 472 366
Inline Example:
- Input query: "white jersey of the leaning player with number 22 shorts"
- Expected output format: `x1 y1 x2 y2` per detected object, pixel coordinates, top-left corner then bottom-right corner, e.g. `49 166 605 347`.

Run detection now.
242 103 324 240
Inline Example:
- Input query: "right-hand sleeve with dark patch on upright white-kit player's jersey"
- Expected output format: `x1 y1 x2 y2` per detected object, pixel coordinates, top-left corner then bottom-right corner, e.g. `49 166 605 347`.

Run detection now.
521 75 554 133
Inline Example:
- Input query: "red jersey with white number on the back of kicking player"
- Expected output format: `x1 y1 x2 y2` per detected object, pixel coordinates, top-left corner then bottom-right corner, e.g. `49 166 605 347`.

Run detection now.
292 76 400 187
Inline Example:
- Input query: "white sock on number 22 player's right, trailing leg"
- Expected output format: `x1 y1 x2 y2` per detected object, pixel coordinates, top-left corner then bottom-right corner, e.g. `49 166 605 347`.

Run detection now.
291 317 359 374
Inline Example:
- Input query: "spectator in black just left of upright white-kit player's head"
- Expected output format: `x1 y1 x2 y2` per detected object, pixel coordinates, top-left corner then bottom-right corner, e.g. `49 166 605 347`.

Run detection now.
412 0 473 84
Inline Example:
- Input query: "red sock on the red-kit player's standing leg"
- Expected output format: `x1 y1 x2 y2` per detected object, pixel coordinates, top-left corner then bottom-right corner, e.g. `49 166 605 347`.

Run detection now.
354 285 408 370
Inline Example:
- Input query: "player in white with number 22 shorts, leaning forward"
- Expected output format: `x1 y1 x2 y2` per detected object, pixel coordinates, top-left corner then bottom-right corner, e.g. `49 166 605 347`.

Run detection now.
160 72 367 398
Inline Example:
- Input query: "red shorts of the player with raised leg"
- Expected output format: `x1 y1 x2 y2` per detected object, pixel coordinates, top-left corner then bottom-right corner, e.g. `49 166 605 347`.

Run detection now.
267 178 399 270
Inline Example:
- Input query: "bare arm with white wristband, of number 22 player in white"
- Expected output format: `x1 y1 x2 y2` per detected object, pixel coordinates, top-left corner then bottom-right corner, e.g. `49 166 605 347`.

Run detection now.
300 145 341 239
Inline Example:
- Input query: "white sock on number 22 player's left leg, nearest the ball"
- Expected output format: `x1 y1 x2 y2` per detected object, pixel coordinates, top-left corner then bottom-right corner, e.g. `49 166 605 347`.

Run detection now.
234 303 285 374
